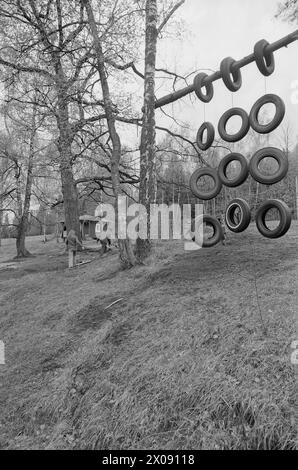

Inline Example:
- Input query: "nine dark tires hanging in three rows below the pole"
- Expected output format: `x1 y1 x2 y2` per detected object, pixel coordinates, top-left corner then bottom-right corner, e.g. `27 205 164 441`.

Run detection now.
190 89 292 247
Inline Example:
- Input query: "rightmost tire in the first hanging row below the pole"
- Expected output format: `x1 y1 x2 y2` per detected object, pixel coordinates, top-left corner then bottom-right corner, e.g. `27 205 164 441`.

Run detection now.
249 94 286 134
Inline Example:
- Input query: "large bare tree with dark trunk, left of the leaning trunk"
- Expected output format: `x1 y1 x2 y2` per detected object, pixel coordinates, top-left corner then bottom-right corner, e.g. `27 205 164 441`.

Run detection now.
0 0 94 239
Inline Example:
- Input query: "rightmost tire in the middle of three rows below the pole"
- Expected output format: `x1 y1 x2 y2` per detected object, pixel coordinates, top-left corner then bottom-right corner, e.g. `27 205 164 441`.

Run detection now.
249 147 289 185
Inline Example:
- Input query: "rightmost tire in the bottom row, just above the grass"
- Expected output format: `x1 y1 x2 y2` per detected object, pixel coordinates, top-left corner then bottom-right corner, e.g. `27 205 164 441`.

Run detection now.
256 199 292 238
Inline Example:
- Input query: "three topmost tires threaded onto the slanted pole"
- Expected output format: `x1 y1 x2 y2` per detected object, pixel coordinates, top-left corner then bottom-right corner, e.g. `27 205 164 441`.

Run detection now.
193 39 275 103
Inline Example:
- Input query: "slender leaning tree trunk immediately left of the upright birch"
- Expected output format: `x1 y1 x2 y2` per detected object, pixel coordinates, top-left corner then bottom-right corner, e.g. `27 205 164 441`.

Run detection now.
82 0 136 267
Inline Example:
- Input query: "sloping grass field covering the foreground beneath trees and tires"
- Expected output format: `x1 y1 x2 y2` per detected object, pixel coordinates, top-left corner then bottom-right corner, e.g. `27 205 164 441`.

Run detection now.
0 223 298 450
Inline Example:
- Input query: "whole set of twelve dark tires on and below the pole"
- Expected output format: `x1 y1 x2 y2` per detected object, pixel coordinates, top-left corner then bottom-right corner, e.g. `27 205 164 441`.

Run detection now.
190 39 291 247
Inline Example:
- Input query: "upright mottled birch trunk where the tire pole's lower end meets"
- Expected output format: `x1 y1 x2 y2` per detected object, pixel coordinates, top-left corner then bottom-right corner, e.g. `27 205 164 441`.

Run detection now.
137 0 157 260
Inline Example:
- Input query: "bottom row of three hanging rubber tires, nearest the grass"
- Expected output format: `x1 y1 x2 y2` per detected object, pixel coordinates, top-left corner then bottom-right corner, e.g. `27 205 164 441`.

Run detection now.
194 198 292 248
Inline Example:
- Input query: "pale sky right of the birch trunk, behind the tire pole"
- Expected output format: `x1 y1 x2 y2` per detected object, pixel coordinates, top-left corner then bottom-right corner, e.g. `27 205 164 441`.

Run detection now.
136 0 298 150
